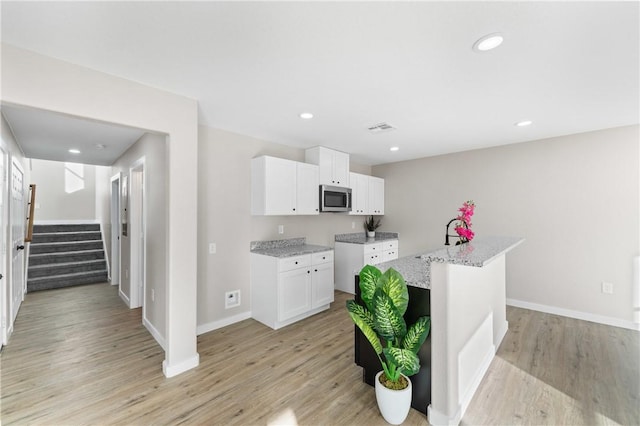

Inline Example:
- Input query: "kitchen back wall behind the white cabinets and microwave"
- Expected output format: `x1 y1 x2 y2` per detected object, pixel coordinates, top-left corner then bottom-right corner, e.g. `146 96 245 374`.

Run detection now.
198 126 372 333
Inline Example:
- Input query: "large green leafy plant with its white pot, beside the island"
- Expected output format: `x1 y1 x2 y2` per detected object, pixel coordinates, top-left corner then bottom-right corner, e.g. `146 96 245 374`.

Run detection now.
347 265 431 424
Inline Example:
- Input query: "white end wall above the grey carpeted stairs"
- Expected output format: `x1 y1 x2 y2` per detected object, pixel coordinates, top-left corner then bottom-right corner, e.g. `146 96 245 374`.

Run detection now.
30 159 96 221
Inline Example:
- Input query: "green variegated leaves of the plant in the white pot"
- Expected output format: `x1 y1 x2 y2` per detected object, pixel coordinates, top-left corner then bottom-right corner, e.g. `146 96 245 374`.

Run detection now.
347 265 431 383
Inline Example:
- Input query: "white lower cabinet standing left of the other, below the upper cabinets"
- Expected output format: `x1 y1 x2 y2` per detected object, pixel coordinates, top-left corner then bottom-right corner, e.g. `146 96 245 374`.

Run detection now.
251 251 333 329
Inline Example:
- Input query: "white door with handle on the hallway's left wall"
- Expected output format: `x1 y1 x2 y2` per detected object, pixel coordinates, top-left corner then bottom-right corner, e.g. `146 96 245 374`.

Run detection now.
9 161 25 324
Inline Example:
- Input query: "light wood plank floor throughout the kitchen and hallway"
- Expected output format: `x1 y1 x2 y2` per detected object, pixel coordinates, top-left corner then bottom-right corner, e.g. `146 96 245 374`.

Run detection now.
0 284 640 426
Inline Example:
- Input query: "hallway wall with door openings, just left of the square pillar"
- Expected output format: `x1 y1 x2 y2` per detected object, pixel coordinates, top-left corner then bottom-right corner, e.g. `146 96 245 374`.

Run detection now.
112 133 167 341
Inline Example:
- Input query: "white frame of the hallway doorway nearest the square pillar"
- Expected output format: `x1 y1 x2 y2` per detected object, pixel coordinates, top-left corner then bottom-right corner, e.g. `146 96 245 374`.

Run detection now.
129 157 147 312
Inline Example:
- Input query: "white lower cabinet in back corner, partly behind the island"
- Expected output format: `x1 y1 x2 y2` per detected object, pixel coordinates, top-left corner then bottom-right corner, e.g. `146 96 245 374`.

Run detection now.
335 240 398 294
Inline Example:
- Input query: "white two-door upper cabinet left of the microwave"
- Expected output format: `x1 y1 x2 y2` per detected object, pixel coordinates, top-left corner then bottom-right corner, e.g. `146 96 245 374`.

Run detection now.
251 156 319 215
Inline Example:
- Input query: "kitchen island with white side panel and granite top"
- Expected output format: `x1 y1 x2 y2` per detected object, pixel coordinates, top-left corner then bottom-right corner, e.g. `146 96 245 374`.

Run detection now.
355 237 524 425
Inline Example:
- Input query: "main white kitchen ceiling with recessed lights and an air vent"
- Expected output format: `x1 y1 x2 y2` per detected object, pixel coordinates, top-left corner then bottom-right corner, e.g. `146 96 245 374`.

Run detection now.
0 1 640 164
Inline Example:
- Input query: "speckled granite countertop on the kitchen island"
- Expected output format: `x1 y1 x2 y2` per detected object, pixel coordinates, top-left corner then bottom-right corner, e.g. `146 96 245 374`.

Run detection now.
377 237 524 289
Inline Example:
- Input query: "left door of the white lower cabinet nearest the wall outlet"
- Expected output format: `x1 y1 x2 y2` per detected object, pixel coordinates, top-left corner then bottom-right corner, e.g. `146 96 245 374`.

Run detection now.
278 268 311 321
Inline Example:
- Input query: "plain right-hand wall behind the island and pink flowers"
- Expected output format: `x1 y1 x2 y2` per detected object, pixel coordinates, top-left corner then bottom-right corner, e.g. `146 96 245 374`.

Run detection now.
373 126 640 327
